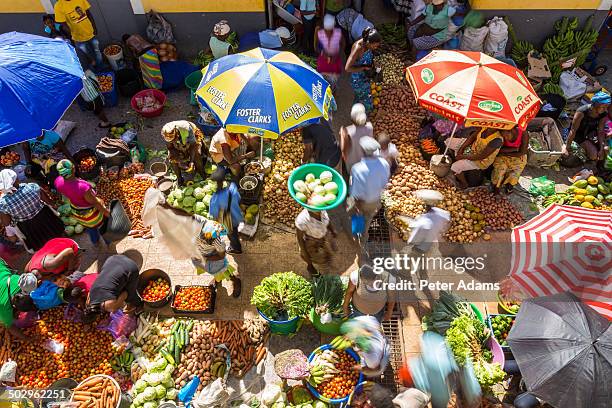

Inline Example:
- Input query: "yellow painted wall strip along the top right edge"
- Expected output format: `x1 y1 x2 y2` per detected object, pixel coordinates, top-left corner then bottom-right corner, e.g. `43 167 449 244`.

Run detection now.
470 0 601 10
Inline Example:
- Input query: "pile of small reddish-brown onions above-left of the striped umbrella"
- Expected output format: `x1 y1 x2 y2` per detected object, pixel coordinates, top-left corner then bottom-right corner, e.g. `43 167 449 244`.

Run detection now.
468 188 523 231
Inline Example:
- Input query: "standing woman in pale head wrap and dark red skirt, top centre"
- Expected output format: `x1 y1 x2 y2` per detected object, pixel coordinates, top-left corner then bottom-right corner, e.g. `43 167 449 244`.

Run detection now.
315 14 343 91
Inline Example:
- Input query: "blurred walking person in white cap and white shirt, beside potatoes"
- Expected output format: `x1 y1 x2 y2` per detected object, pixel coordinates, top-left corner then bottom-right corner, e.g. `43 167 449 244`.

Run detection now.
408 190 450 253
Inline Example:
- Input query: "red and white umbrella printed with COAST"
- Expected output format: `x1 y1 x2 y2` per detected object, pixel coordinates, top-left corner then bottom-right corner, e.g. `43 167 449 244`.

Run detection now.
406 50 541 129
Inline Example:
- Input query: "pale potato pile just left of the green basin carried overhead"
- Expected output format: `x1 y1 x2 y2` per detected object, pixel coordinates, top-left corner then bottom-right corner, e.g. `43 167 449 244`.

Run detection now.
263 131 304 226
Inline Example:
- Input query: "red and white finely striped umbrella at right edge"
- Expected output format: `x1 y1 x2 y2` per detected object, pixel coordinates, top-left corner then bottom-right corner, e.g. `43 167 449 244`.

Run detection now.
510 204 612 320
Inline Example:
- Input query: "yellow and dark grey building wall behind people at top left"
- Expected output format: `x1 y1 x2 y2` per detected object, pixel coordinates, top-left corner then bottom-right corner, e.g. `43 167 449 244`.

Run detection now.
0 0 267 56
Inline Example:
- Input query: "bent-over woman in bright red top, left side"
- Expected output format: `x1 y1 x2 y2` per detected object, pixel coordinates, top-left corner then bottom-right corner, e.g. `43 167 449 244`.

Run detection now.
25 238 81 279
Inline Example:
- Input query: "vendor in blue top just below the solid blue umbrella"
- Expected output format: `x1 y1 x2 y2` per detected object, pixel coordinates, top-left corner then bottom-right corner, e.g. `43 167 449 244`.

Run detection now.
21 130 73 185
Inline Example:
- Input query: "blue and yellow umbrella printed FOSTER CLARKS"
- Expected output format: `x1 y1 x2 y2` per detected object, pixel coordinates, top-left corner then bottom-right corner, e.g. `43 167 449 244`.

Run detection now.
196 48 333 139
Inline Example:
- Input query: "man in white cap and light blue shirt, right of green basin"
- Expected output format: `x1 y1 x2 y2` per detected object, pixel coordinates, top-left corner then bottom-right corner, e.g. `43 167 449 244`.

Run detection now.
349 136 391 257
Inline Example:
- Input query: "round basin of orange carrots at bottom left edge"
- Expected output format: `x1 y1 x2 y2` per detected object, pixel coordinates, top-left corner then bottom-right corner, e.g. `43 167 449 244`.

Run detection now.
72 375 121 408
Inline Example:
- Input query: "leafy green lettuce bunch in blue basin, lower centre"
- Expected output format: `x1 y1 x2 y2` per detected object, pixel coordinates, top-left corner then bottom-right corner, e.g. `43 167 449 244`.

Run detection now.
251 272 313 320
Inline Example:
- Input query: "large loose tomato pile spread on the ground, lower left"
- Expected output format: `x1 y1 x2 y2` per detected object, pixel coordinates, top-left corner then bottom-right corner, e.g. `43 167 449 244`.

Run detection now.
15 308 115 388
